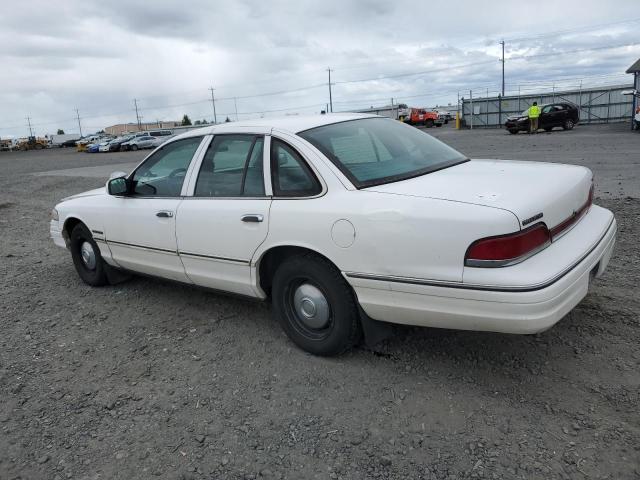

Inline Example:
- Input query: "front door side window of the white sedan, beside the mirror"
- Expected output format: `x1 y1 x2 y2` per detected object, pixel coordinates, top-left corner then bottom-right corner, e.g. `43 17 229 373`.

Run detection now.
133 137 202 197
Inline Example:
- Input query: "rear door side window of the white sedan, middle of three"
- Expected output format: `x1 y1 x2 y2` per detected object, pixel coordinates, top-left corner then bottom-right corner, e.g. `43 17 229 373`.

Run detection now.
195 135 264 197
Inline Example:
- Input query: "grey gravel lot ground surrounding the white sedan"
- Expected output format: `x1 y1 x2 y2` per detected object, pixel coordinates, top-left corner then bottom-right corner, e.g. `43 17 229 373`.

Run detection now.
0 126 640 480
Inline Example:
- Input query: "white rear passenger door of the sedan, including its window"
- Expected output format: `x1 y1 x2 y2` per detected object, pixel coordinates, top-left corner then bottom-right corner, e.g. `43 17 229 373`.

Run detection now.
176 133 271 296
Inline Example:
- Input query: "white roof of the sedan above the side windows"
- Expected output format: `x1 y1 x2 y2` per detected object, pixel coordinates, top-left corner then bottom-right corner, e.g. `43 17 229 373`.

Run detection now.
174 113 385 138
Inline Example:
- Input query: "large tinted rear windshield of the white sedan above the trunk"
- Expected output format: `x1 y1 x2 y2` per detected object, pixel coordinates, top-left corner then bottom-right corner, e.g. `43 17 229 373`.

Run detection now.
298 118 467 188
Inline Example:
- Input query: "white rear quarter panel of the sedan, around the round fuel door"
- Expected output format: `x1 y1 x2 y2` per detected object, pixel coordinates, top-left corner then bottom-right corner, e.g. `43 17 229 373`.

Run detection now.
256 190 519 281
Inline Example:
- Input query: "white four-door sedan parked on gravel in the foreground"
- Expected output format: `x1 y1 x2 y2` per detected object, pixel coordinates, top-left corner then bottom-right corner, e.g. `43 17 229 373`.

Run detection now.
51 114 616 355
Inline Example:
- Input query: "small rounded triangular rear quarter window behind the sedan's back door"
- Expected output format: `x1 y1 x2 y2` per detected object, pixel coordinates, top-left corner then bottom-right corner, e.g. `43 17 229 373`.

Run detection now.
271 138 322 197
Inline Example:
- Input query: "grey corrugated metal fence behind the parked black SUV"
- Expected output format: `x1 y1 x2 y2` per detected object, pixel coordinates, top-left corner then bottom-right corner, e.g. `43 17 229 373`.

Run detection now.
460 85 633 128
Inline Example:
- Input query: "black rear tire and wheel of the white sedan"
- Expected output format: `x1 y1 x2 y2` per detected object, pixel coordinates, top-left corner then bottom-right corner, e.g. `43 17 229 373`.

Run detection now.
272 254 361 356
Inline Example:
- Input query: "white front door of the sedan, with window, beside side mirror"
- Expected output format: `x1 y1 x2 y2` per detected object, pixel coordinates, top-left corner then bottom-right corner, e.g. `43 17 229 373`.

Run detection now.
104 136 203 281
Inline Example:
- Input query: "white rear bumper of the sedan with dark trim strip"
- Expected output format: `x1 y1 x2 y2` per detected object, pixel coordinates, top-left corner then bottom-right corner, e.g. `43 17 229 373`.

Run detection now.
345 210 617 334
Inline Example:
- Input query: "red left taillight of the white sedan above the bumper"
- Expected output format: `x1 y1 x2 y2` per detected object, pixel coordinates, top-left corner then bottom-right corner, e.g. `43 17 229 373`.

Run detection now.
464 223 551 267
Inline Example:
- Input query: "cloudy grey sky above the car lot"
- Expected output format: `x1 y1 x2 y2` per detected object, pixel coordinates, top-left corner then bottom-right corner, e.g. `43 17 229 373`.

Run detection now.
0 0 640 138
